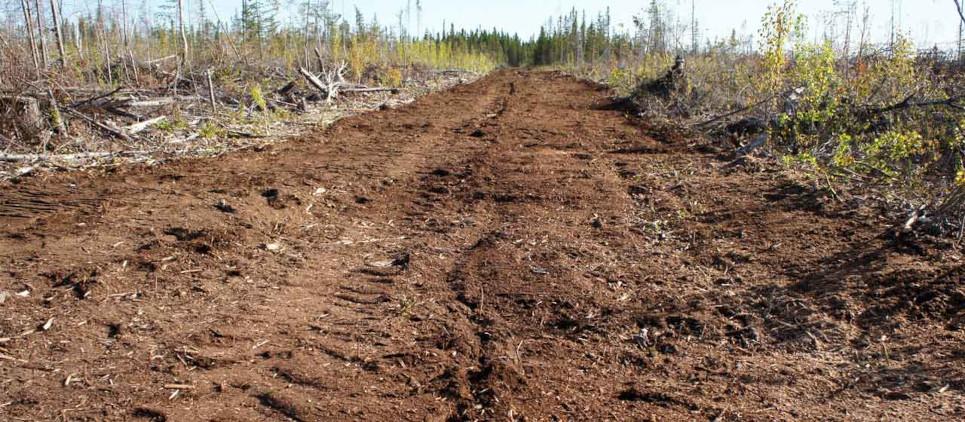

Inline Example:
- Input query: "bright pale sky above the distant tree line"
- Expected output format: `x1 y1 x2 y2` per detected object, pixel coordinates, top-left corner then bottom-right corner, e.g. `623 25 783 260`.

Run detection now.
45 0 959 50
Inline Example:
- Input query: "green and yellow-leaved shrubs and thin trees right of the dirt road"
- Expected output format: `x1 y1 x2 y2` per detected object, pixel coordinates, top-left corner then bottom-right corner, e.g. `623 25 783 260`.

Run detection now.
516 0 965 234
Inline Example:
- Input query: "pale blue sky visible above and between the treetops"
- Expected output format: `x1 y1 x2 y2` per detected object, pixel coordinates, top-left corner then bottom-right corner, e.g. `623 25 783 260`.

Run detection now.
64 0 959 48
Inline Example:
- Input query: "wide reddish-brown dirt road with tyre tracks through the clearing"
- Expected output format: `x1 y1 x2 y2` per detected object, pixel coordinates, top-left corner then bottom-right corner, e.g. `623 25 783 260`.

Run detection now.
0 71 965 421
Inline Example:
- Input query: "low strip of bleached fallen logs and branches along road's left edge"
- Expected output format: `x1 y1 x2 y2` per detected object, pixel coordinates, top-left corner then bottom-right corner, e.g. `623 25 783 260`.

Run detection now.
0 59 477 180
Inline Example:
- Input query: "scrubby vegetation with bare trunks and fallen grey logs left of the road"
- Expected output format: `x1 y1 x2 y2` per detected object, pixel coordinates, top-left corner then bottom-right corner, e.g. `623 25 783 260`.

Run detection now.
0 0 507 172
